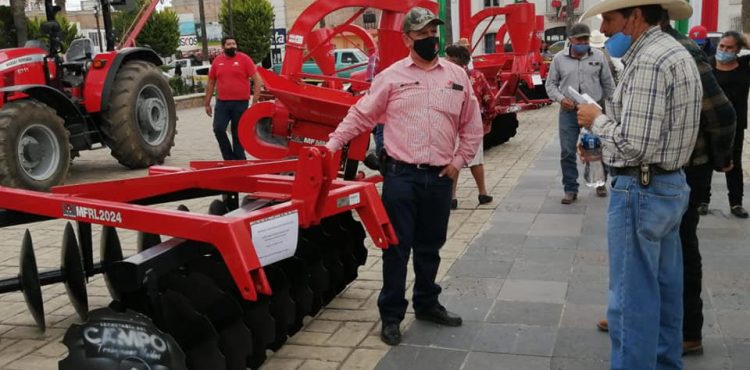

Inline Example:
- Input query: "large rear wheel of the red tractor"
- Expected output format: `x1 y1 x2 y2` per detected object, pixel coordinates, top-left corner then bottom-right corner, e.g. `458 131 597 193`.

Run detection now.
101 60 177 168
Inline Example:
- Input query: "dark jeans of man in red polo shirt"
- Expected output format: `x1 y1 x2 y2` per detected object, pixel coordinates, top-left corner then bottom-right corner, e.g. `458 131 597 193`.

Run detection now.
214 100 248 160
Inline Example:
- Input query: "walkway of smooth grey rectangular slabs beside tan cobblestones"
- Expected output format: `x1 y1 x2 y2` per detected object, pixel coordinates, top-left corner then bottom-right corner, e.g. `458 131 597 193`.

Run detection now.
377 125 750 370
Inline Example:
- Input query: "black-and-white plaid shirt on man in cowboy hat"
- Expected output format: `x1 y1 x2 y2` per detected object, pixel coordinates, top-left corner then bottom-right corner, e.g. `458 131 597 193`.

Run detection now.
591 27 703 170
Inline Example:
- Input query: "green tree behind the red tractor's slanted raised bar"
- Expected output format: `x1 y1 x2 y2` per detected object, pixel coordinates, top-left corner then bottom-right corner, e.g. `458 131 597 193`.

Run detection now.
112 0 180 56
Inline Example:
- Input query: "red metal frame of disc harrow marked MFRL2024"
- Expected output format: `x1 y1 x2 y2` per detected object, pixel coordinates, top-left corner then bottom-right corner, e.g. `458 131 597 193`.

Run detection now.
0 147 398 300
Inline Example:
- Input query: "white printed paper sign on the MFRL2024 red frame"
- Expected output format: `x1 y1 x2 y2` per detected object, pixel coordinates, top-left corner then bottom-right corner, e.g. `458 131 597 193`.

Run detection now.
250 211 299 266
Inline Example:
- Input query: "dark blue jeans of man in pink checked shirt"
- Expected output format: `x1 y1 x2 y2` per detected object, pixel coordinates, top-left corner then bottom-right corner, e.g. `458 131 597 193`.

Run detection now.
378 161 453 323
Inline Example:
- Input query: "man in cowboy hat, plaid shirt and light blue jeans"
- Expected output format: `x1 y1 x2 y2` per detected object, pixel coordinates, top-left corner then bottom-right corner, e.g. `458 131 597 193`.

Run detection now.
578 0 703 369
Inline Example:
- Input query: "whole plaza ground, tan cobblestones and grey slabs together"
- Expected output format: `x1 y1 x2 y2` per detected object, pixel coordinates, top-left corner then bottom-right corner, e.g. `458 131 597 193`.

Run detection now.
0 107 750 370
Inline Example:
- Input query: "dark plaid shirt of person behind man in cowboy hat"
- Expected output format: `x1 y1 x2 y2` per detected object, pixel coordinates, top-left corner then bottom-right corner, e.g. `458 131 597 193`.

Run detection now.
665 27 737 170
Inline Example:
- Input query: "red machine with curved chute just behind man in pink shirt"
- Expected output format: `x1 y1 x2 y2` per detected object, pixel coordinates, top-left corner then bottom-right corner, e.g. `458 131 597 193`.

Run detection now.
239 0 438 160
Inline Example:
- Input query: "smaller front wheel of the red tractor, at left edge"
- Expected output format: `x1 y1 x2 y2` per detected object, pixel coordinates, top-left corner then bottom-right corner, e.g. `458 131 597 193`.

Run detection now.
0 99 71 191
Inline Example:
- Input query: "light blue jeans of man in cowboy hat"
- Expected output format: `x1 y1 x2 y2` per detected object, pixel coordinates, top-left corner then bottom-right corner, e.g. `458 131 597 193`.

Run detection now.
607 170 690 370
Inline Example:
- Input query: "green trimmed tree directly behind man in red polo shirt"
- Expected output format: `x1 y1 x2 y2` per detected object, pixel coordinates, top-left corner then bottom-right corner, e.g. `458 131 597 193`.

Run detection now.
219 0 273 63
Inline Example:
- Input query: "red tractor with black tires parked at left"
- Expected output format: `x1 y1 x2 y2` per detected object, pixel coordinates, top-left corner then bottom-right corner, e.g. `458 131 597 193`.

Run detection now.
0 0 177 191
